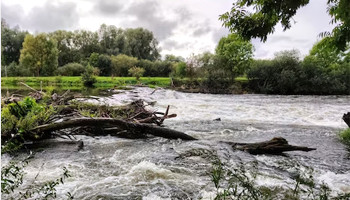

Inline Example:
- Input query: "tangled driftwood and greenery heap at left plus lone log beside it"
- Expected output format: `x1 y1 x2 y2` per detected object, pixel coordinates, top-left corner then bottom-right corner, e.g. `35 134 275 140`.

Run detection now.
1 86 326 154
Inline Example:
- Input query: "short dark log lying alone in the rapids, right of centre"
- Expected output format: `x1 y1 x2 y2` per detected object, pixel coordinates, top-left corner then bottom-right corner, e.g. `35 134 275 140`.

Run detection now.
226 137 316 155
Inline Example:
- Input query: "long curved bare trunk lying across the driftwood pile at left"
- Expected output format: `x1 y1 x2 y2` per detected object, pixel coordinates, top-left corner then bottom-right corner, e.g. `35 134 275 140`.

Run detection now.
31 118 196 140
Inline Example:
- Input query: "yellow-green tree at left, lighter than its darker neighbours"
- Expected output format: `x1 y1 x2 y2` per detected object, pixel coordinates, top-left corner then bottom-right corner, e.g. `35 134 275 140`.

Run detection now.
20 33 58 76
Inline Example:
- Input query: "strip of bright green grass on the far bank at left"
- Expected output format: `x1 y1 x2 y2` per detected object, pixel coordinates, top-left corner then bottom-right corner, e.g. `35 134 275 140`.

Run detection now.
1 76 170 88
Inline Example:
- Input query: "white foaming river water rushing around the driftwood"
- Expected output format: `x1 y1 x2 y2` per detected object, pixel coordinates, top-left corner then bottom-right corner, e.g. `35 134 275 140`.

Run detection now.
2 88 350 200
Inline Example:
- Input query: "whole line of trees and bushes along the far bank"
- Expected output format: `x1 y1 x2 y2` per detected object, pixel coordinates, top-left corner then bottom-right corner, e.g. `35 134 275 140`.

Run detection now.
1 20 350 95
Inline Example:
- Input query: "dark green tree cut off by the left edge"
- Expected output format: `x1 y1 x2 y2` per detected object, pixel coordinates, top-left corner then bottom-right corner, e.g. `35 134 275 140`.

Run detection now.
1 19 28 65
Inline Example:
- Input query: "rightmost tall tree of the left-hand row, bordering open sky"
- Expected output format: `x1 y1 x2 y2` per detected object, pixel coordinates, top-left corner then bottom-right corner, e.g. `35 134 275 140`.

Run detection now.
124 28 160 61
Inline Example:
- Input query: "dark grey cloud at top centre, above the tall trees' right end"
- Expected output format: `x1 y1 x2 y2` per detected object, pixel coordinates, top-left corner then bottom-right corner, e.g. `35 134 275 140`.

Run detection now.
124 1 181 40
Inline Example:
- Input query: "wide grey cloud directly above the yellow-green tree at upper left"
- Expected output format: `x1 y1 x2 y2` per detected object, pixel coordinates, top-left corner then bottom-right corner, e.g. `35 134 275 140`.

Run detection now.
23 2 79 32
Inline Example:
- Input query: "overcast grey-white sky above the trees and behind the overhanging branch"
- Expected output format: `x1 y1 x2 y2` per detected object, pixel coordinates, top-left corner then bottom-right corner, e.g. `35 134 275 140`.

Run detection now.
1 0 332 58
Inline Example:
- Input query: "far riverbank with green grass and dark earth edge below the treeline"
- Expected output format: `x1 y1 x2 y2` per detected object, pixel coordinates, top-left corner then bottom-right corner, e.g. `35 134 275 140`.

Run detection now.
1 76 252 94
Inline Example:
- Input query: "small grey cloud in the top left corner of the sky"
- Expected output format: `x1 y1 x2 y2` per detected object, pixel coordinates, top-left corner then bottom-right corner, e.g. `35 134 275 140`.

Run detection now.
1 1 24 27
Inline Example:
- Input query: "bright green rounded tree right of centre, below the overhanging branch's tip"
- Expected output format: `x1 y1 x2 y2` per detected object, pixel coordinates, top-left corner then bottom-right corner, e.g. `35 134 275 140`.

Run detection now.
216 34 253 82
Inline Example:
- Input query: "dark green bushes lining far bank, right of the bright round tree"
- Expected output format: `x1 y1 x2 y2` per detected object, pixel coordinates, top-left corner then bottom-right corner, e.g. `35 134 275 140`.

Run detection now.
247 51 350 95
